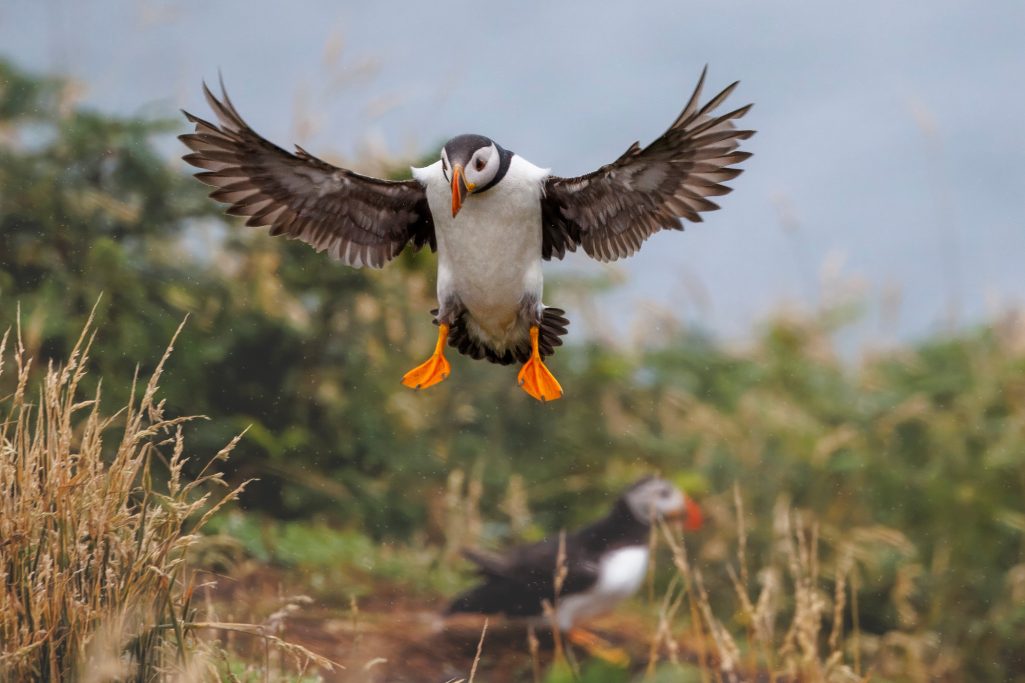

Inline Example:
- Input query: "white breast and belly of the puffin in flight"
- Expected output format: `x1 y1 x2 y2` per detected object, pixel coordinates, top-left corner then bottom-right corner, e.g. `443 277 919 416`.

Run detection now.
413 156 548 349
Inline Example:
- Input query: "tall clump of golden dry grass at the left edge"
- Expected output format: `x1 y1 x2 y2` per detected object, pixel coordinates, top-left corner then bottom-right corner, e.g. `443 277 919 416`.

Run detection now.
0 311 330 681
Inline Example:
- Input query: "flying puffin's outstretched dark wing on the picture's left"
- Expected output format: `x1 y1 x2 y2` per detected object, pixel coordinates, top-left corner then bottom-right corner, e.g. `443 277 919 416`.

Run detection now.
178 84 436 268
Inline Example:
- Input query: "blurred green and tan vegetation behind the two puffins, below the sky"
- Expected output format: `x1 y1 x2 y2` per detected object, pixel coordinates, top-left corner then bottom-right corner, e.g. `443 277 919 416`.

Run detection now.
0 63 1025 681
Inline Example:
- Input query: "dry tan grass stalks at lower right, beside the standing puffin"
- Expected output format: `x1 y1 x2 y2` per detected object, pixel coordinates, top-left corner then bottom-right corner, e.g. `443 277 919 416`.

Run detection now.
649 490 869 683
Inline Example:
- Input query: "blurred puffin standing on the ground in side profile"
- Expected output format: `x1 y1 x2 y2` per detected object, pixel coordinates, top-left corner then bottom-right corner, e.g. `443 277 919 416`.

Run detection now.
448 477 702 642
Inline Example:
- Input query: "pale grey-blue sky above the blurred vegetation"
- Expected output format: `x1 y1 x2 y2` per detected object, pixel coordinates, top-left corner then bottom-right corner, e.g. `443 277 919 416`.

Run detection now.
0 0 1025 345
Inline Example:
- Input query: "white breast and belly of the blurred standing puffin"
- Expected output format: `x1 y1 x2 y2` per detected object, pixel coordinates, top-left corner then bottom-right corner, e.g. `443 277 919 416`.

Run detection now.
557 546 648 631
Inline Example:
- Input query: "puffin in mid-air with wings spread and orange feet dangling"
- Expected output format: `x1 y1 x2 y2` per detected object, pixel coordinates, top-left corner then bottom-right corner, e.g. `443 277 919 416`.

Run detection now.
179 68 753 401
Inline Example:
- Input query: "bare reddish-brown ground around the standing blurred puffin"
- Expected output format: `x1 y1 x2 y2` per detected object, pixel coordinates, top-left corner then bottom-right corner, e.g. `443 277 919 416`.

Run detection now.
199 567 713 683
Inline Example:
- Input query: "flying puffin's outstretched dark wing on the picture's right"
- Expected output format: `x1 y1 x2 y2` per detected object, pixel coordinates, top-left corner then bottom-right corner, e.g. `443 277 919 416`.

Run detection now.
541 68 754 262
